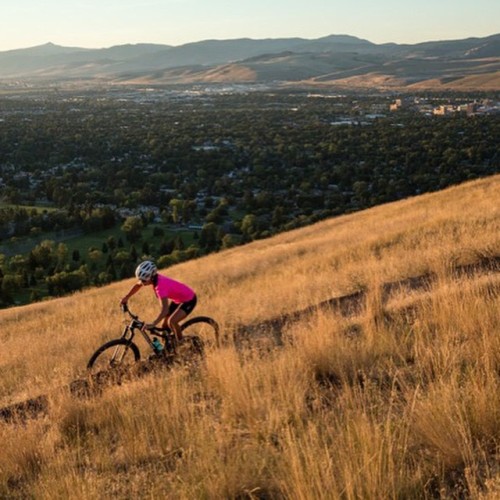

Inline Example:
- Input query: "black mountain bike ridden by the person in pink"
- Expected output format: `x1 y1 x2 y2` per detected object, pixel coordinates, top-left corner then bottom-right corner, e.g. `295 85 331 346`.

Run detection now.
87 304 220 372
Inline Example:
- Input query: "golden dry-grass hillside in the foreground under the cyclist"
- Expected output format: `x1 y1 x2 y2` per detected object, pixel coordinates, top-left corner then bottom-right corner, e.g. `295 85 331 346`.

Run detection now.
0 176 500 499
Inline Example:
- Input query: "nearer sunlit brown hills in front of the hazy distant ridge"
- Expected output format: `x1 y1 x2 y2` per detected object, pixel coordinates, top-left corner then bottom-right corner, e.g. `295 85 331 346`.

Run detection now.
118 52 500 91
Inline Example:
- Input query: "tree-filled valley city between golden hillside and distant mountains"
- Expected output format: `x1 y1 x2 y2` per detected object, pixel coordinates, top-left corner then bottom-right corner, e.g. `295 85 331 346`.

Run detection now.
0 84 500 306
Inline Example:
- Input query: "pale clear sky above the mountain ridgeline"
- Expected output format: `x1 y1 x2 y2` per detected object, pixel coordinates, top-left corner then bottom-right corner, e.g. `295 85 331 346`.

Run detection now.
0 0 500 51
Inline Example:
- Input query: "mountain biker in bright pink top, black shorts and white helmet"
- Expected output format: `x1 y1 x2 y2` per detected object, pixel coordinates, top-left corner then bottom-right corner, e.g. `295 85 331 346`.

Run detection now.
121 260 197 342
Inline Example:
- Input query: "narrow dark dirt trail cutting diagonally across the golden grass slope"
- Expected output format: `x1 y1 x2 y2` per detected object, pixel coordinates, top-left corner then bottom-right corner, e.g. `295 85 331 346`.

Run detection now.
0 256 500 422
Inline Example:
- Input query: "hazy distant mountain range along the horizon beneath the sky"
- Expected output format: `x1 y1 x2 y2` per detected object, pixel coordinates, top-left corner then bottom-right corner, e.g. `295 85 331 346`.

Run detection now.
0 34 500 90
